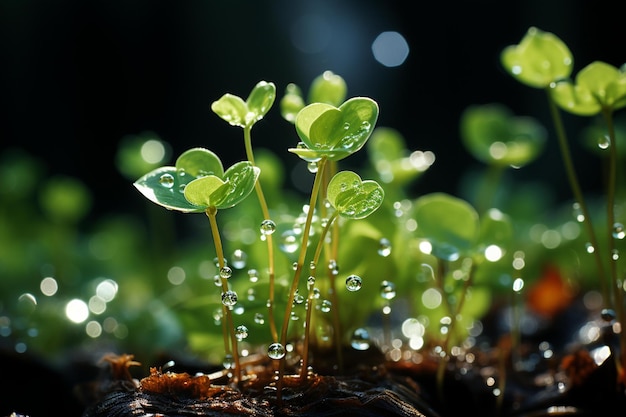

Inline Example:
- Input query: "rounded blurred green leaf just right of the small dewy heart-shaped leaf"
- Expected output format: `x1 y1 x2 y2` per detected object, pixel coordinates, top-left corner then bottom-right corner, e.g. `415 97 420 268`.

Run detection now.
414 193 479 261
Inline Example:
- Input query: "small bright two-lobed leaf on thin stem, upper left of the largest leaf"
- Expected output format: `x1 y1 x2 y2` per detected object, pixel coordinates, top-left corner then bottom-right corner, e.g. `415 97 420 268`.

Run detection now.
211 81 276 127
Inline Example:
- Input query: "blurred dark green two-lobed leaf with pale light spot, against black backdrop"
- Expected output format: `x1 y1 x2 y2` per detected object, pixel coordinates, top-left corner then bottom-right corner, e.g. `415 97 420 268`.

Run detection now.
460 104 547 168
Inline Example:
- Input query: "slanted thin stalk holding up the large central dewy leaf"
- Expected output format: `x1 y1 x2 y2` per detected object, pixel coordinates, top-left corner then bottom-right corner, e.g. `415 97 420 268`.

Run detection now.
278 158 326 392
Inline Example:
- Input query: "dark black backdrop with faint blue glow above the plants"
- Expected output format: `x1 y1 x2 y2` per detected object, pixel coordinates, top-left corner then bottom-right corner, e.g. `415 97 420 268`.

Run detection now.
0 0 626 212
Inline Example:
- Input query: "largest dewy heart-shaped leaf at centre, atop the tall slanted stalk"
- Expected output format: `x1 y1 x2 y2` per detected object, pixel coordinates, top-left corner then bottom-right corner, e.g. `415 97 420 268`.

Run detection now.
289 97 378 161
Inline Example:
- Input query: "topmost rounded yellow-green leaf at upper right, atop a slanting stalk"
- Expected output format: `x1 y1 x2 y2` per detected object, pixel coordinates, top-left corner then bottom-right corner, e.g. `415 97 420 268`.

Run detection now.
500 27 573 88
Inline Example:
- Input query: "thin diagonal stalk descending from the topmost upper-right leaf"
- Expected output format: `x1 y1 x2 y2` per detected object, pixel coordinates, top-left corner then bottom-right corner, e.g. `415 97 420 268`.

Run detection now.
546 89 611 303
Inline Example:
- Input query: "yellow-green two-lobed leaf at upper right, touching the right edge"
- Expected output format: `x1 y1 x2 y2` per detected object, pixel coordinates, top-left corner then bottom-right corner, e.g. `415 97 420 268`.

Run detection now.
551 61 626 116
